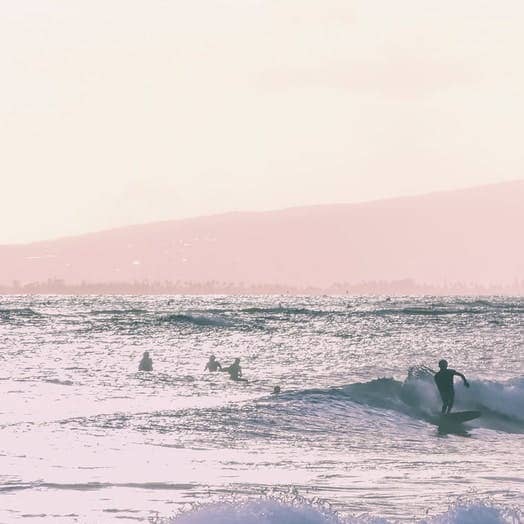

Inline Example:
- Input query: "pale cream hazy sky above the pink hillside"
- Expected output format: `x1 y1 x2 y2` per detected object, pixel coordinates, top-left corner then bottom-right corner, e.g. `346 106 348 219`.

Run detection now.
0 0 524 243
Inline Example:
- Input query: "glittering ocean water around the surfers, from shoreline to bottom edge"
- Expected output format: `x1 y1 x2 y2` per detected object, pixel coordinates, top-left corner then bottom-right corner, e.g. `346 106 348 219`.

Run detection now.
0 296 524 524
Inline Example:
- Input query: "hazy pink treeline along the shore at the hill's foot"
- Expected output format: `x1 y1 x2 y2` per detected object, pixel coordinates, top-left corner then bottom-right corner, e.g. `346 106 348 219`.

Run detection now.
0 279 524 296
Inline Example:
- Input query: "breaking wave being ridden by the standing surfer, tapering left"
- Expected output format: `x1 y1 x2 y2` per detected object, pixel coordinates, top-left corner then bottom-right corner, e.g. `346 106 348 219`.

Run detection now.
67 375 524 438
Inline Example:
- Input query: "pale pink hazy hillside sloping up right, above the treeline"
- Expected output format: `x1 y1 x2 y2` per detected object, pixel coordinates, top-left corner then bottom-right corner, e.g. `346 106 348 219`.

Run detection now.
0 181 524 287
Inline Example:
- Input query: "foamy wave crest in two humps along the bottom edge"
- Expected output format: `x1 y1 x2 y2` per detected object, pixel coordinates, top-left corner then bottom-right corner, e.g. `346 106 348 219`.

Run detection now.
163 497 523 524
